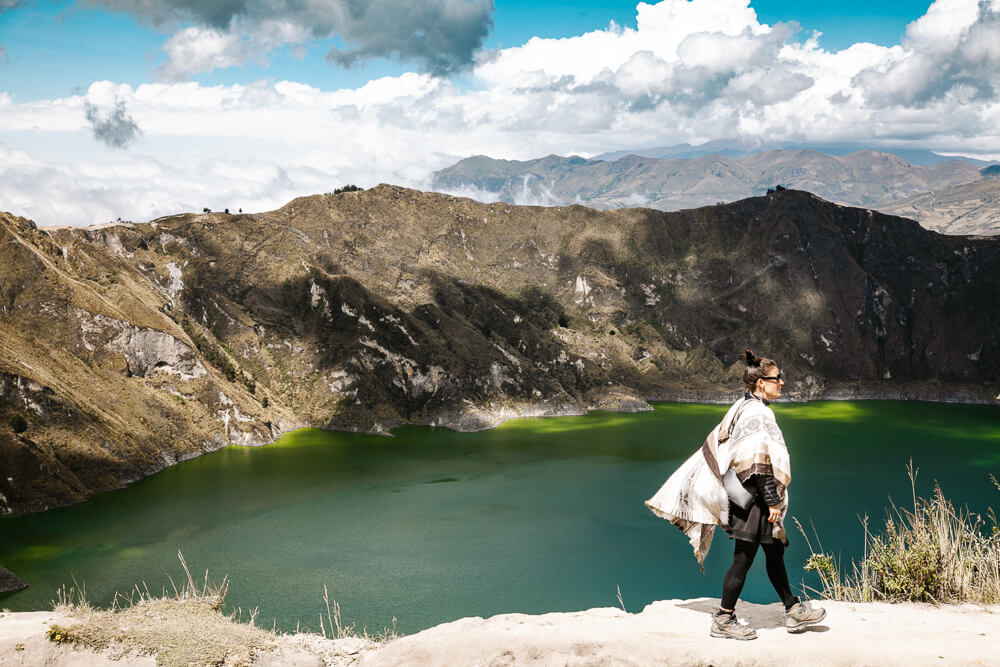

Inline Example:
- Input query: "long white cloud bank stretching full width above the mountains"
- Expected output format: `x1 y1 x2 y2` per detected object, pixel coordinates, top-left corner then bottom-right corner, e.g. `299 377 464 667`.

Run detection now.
0 0 1000 224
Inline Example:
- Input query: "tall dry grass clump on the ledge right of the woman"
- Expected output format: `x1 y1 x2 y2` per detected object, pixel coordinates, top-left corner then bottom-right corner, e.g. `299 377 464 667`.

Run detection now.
796 461 1000 604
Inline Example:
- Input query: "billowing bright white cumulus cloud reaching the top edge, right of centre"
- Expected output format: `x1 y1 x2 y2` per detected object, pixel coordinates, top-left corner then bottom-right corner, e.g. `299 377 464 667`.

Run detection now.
476 0 814 114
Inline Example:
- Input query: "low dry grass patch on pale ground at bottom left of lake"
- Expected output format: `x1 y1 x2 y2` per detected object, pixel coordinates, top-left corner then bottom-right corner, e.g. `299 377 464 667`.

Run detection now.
48 551 396 667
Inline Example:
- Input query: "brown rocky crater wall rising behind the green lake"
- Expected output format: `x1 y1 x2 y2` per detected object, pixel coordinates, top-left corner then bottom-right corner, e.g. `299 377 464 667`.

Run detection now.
0 185 1000 512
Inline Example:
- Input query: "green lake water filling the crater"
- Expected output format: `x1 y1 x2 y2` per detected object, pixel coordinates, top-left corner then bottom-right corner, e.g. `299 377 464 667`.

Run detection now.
0 401 1000 633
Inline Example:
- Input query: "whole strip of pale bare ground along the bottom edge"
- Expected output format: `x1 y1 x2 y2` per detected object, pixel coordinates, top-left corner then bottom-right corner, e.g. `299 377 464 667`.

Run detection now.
0 598 1000 667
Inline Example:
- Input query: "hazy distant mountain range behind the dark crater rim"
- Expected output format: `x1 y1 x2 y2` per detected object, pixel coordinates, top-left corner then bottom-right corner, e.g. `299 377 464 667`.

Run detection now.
432 151 998 234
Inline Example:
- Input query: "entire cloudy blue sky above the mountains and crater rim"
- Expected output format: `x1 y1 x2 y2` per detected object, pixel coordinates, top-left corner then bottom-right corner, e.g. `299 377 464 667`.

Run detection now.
0 0 1000 224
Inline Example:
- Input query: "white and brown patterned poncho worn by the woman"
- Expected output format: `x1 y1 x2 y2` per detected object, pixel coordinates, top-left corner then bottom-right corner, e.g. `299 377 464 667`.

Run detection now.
646 398 792 569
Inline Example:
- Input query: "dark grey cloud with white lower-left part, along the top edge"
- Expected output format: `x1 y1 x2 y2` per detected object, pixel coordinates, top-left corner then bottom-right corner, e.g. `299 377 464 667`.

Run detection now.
88 0 493 80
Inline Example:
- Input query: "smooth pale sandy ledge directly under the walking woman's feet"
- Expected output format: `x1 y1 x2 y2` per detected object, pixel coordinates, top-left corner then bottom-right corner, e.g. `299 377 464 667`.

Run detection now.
361 598 1000 667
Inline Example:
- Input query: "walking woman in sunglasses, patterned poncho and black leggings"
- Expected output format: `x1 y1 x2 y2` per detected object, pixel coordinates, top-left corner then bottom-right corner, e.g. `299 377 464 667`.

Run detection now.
646 350 826 640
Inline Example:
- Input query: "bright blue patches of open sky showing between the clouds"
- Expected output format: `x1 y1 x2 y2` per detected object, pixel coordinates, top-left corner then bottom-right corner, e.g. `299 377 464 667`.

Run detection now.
0 0 928 101
